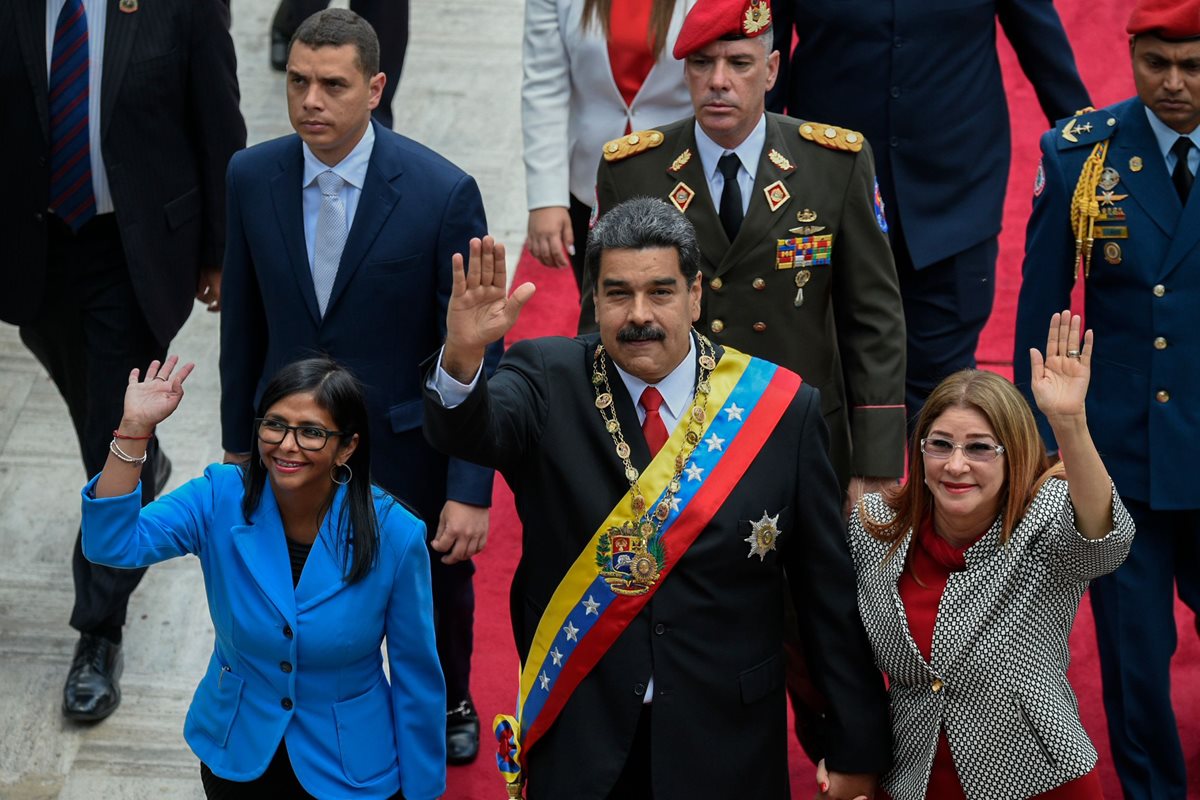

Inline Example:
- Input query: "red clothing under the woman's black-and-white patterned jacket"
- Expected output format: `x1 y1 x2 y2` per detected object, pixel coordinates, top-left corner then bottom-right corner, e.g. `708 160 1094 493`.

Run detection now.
899 517 1104 800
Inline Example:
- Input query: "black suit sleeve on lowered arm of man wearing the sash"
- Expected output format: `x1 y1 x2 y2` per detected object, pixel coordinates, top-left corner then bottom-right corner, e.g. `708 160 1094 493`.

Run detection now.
785 389 892 774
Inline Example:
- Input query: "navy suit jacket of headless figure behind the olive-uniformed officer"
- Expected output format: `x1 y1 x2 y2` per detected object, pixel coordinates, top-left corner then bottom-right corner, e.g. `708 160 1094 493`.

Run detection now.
770 0 1088 269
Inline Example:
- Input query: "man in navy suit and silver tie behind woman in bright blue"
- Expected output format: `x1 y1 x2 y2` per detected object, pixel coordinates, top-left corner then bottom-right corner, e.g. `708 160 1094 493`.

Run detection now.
221 8 499 763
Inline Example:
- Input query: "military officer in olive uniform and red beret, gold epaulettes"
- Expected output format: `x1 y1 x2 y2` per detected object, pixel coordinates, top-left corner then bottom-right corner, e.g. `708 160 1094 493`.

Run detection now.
580 0 905 497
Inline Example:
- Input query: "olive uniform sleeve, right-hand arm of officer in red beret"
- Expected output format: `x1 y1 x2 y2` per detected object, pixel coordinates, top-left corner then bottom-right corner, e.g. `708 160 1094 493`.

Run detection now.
833 141 905 477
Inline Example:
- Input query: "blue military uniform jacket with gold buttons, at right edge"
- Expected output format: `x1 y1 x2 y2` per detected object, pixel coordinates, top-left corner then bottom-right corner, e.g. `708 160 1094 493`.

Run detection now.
1013 97 1200 510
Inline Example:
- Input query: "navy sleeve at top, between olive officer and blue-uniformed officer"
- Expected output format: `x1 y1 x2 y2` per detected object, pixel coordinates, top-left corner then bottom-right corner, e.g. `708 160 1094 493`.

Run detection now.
996 0 1091 125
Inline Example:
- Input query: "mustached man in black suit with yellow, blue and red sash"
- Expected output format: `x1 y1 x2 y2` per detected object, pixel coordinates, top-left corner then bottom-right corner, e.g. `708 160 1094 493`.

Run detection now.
425 198 890 800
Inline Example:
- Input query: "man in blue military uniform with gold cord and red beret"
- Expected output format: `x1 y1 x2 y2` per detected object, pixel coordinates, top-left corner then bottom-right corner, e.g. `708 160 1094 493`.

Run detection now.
1013 0 1200 800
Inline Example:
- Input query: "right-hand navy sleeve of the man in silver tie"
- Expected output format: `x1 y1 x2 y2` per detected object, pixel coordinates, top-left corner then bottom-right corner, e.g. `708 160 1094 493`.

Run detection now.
437 175 504 506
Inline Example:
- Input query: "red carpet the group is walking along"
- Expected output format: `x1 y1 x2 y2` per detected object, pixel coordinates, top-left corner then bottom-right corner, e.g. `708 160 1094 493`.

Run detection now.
446 0 1200 800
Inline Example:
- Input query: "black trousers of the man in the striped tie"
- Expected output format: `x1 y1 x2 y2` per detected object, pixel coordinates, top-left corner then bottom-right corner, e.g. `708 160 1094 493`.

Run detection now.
20 213 166 639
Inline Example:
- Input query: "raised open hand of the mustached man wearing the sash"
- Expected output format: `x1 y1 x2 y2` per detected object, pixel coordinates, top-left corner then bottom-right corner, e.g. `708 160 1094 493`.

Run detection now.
442 236 535 383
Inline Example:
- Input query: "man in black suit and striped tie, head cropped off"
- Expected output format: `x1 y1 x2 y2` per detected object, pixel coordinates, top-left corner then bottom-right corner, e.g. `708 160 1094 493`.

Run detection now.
0 0 246 720
